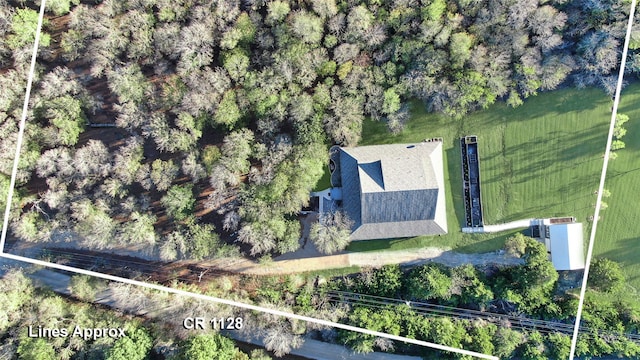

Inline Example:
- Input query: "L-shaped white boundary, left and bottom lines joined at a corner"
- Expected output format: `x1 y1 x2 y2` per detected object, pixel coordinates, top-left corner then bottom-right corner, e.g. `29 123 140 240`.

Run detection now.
0 0 498 360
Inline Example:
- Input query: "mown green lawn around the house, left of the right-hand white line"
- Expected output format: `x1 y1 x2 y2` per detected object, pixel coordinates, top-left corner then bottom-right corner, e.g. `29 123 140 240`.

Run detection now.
349 89 608 252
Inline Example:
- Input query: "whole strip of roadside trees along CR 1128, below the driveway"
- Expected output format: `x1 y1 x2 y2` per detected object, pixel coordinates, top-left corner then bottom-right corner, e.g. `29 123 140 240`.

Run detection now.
6 235 640 360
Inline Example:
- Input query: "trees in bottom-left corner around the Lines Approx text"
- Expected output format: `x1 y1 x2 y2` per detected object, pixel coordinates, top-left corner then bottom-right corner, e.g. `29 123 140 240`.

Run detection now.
0 269 271 360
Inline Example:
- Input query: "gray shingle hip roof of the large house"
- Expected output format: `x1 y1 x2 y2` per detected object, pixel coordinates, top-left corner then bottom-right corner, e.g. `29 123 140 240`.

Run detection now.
340 142 447 240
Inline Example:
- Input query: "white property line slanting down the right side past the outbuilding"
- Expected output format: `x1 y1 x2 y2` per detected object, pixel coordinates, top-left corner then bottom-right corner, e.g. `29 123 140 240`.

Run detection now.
569 0 636 360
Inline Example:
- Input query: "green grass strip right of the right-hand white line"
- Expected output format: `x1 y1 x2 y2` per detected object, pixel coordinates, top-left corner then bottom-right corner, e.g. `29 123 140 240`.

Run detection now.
594 83 640 292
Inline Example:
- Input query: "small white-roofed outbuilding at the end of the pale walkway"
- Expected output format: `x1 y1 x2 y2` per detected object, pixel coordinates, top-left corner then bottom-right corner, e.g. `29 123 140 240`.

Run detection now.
531 217 585 270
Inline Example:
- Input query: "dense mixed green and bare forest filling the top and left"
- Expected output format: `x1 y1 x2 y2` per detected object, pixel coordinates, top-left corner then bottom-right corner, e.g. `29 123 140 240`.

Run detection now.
0 0 640 260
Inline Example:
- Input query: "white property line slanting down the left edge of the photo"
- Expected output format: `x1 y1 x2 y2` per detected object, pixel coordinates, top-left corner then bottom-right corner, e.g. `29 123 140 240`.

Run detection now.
0 0 46 254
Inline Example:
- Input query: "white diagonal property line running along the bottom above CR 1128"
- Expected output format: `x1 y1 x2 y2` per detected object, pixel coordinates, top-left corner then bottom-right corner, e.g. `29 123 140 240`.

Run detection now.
0 253 498 360
